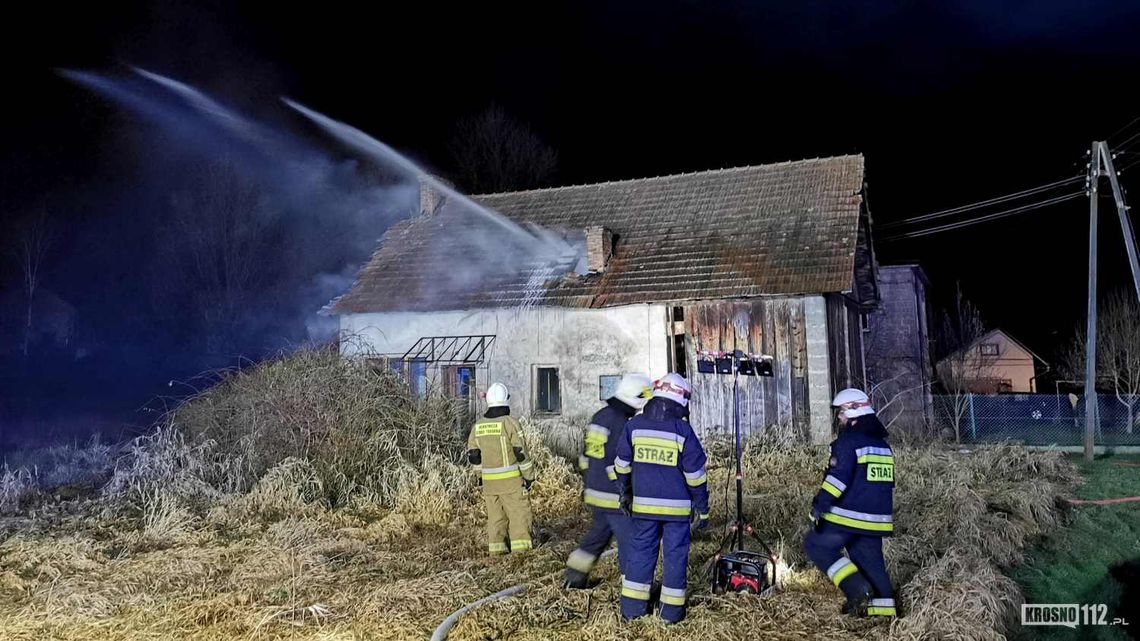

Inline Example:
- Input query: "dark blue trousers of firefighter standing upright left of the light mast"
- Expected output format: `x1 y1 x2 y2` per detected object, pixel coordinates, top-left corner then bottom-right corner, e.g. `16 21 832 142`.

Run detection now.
618 518 690 623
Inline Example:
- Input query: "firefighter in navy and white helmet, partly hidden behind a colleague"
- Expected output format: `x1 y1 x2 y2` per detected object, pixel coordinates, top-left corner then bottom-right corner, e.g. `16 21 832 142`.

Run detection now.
565 373 653 589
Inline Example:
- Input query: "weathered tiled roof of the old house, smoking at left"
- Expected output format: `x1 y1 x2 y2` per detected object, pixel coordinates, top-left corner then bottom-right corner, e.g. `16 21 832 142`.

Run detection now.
326 155 863 315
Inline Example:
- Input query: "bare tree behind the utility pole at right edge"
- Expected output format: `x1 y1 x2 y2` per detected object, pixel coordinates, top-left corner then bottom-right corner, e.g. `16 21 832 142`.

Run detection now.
1060 291 1140 433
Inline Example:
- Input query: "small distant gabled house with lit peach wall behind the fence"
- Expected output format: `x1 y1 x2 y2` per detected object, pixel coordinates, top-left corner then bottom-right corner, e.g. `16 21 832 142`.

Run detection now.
938 330 1048 393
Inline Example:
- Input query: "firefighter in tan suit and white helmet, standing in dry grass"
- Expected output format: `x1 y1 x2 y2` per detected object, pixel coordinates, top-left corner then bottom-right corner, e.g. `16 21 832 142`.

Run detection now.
467 383 535 555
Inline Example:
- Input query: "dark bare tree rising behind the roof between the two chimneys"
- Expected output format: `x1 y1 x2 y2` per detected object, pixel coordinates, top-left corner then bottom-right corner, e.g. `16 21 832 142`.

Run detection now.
449 105 559 193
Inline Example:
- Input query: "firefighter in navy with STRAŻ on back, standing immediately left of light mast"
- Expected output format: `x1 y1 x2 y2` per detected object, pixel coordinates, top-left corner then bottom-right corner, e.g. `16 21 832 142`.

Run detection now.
613 374 709 623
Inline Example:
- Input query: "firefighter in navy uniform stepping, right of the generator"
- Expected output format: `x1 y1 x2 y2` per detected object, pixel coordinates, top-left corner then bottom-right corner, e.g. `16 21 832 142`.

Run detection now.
804 389 896 617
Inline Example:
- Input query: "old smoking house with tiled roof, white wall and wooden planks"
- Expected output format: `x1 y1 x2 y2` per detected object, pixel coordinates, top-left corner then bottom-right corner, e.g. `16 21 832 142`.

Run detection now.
326 155 878 443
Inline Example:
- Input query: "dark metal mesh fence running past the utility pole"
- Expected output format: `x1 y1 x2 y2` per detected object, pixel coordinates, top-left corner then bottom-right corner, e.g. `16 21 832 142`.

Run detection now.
934 393 1140 447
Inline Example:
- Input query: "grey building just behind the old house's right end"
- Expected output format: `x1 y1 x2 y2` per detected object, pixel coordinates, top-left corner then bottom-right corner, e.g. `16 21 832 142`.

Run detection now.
864 265 934 431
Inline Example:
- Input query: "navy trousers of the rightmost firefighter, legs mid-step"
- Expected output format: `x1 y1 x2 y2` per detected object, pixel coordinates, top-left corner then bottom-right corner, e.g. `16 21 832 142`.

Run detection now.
804 524 896 616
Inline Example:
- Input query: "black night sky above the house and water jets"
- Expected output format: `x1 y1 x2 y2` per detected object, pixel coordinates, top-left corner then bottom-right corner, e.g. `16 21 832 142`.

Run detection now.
0 0 1140 433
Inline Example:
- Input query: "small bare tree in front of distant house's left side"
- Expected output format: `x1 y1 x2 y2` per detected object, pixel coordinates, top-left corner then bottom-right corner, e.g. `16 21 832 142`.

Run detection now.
937 287 986 443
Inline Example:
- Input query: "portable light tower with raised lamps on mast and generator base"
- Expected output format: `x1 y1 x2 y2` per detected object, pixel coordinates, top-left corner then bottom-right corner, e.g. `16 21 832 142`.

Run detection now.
698 350 776 597
